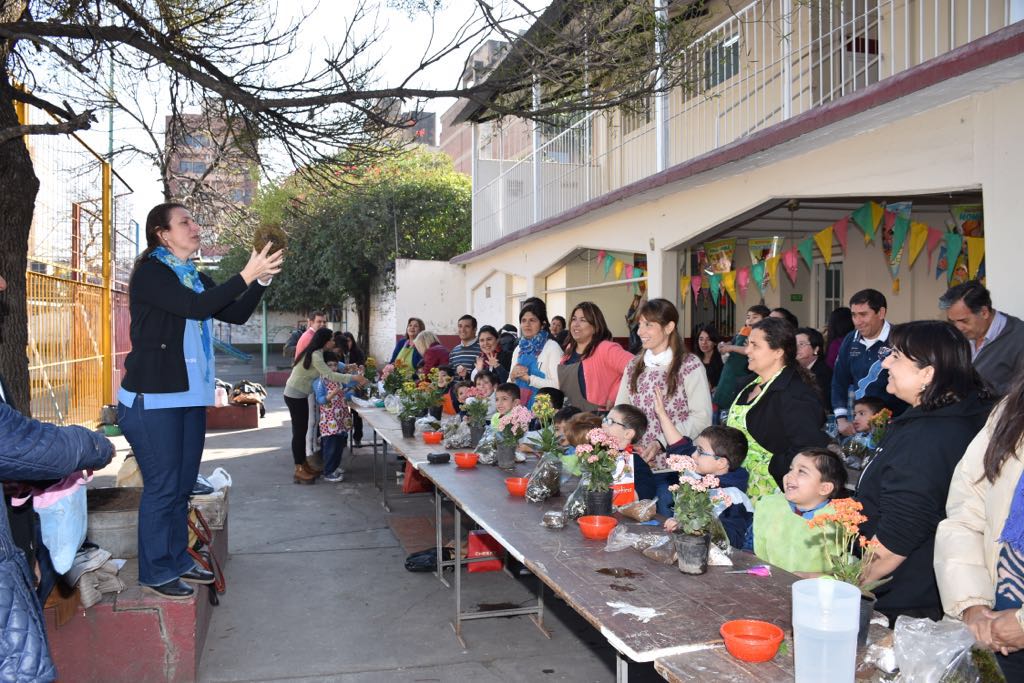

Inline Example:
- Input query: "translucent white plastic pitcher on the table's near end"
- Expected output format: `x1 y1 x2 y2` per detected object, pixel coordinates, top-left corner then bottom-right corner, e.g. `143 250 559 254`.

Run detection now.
793 579 860 683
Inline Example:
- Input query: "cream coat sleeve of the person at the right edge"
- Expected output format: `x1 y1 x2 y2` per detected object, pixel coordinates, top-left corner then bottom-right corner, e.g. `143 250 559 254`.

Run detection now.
935 417 999 618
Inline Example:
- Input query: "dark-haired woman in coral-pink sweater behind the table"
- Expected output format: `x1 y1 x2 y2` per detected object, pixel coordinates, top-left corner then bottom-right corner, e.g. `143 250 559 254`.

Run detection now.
558 301 633 411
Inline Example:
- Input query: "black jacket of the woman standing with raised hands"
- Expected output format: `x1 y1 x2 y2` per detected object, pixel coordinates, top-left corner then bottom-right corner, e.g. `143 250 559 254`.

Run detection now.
121 258 266 393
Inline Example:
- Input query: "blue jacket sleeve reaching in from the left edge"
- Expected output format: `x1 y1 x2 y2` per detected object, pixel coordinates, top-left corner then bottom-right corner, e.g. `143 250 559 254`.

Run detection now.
0 403 114 481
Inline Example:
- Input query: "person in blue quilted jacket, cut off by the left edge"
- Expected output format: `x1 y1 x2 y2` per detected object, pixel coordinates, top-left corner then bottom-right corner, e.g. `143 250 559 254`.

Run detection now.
0 276 114 683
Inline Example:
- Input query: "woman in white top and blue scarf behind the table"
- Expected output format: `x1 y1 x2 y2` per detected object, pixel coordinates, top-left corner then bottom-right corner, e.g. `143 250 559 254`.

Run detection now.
509 300 562 408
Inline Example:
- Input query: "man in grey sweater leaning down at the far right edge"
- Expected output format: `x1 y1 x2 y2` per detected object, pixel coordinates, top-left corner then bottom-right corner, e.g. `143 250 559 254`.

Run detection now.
939 280 1024 396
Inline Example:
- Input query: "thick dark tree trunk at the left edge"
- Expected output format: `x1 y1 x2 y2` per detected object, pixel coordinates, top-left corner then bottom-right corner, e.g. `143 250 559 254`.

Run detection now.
0 77 40 415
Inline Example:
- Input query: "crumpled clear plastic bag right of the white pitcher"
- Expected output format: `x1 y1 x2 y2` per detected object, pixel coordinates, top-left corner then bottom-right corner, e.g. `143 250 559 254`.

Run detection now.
893 615 981 683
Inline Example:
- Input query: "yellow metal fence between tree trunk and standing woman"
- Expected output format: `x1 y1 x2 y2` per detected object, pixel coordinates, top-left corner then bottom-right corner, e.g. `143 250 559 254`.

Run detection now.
19 99 137 424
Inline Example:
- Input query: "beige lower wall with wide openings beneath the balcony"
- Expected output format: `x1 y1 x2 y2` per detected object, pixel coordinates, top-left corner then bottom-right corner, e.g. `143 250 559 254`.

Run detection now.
467 76 1024 329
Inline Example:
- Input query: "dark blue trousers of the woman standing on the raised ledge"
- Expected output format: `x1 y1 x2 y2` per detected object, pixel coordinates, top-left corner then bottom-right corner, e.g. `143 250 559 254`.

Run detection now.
118 394 206 586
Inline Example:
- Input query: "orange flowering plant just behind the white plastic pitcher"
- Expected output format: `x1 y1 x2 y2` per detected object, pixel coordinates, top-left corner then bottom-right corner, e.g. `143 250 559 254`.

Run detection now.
807 498 892 598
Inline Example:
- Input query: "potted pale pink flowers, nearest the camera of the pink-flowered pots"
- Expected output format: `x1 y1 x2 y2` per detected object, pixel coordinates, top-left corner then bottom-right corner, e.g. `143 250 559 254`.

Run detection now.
668 456 729 574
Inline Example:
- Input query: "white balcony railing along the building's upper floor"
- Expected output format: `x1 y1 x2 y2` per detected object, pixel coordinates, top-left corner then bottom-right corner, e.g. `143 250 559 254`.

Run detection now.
473 0 1019 249
